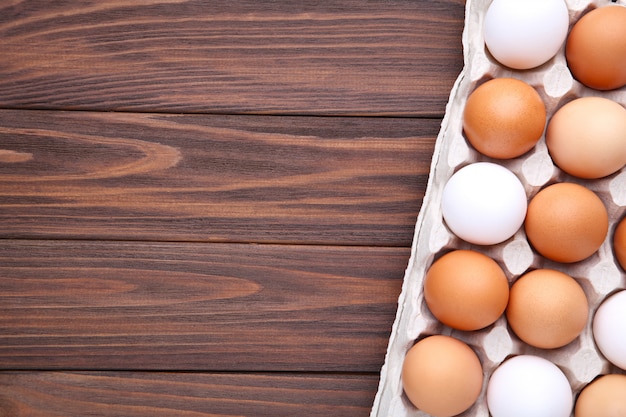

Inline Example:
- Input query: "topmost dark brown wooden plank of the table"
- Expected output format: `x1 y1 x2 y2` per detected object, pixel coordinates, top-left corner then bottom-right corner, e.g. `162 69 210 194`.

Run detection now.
0 0 464 116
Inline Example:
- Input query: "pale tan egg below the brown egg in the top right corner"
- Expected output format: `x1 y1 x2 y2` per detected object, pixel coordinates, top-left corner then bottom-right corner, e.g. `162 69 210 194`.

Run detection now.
546 97 626 179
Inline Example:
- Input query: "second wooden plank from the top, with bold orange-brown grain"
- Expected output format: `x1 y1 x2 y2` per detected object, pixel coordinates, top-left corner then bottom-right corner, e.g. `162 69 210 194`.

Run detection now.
0 110 439 246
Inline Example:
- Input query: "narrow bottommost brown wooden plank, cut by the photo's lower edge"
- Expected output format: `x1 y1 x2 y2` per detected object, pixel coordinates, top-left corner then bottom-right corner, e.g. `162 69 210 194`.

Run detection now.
0 372 377 417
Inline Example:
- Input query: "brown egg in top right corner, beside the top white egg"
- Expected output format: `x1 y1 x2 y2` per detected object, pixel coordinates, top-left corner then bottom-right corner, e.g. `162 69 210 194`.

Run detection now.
565 5 626 90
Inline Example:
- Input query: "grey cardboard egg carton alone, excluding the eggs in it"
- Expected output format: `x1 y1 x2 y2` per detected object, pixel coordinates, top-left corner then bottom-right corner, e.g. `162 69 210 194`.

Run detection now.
371 0 626 417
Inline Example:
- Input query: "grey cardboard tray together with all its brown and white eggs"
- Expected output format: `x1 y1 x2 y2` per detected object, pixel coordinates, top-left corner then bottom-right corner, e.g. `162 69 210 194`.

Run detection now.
371 0 626 417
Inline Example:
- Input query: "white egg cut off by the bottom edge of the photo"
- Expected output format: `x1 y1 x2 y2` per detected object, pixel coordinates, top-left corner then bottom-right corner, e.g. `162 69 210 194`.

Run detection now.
487 355 574 417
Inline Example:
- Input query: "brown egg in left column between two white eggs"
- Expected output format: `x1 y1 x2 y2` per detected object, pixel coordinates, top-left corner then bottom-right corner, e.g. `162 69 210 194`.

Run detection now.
463 78 546 159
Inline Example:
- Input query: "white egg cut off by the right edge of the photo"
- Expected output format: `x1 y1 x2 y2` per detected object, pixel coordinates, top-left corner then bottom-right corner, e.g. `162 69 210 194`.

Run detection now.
593 290 626 370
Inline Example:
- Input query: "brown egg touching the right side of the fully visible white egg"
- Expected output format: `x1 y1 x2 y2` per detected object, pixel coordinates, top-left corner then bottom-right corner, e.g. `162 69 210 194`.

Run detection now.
524 182 609 263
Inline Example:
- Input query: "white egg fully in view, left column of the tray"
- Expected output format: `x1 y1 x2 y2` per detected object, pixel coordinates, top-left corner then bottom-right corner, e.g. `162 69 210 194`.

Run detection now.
441 162 528 245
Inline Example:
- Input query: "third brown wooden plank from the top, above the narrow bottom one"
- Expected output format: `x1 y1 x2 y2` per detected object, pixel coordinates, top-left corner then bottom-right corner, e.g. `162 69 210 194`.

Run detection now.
0 240 409 372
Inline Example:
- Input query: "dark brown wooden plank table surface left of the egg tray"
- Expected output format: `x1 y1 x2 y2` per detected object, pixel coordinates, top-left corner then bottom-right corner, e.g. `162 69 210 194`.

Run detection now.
0 0 465 417
